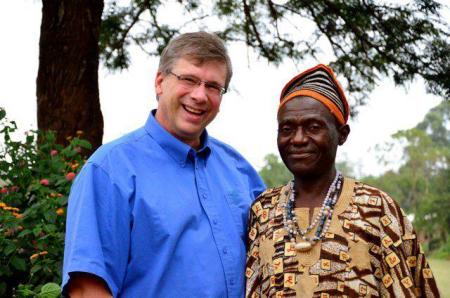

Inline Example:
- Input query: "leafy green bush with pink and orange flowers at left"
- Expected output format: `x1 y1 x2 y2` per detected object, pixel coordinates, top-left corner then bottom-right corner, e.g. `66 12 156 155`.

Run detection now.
0 108 91 297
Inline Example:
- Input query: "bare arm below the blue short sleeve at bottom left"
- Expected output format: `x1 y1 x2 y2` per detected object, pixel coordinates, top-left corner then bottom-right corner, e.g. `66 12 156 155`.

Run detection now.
67 272 112 298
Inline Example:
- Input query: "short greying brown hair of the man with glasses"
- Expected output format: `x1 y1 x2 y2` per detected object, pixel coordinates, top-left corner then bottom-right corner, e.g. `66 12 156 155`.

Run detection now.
158 31 233 89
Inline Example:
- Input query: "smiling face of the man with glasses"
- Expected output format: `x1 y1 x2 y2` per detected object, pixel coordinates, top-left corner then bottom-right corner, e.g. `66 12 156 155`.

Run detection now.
155 58 227 148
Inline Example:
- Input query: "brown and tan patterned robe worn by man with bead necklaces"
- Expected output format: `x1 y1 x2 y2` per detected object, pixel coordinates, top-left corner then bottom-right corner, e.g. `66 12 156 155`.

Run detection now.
246 178 439 298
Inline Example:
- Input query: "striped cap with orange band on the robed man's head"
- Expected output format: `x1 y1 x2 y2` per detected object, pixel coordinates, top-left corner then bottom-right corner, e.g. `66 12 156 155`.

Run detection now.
278 64 350 125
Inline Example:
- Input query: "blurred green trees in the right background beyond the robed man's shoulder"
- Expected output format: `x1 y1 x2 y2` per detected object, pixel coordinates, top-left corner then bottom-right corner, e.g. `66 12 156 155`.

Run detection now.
365 101 450 256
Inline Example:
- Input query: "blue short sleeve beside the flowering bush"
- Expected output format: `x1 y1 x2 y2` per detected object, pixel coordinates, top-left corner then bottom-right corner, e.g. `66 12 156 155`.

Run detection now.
62 162 131 297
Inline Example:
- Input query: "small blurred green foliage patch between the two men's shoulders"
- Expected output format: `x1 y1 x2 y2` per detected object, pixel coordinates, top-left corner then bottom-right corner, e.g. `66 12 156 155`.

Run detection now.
259 153 293 187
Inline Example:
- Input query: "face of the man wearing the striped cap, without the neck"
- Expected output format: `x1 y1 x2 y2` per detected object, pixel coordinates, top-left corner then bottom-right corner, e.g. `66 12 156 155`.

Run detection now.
277 96 349 178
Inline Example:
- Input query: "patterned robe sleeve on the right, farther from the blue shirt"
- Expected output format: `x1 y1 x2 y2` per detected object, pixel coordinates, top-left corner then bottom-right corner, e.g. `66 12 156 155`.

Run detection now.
380 195 440 297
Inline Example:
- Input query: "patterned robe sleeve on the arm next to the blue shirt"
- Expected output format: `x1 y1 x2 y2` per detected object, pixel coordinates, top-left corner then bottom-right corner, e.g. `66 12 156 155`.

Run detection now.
245 201 262 298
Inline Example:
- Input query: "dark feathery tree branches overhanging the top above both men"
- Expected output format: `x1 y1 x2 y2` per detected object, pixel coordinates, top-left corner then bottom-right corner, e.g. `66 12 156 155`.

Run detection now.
100 0 450 105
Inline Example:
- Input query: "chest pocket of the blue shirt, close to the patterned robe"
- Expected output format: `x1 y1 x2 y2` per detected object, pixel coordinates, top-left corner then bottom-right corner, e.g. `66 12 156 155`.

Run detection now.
225 190 252 237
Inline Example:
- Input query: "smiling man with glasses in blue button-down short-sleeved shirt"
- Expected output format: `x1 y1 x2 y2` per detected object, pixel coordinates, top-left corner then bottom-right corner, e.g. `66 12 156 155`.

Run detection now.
63 32 265 297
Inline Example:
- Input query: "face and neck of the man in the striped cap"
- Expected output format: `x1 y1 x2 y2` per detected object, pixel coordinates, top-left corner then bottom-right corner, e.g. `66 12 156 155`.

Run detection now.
277 96 350 208
